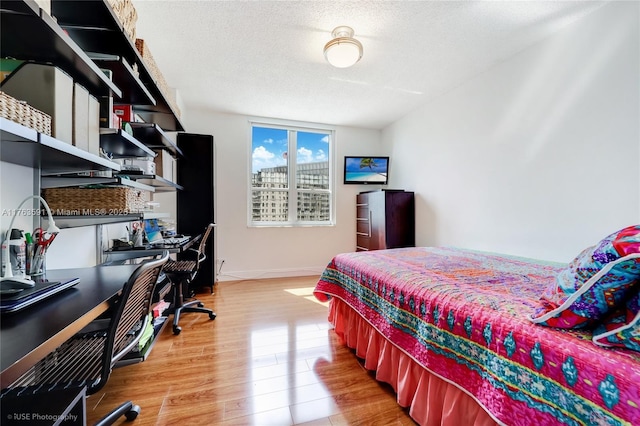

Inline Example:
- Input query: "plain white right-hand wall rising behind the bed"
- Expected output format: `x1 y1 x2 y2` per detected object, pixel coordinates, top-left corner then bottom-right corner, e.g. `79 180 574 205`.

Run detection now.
383 2 640 261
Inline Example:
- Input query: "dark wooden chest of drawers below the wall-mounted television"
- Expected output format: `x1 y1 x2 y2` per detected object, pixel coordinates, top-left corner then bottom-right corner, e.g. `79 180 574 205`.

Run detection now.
356 190 415 251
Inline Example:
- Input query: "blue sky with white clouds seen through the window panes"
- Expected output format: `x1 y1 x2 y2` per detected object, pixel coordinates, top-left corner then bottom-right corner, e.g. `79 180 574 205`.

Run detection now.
251 127 329 173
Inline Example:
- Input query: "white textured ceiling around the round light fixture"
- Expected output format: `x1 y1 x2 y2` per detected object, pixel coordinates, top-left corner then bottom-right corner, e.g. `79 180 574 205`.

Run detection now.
134 0 604 129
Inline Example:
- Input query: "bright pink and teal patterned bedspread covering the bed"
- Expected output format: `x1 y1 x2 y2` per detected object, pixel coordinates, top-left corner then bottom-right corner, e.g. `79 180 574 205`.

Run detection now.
315 247 640 426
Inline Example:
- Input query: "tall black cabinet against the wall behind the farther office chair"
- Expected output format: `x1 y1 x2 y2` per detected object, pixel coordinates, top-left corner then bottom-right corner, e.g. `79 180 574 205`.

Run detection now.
176 133 216 290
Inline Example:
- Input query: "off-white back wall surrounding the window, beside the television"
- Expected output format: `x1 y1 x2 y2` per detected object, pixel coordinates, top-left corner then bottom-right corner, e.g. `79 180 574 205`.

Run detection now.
185 110 383 281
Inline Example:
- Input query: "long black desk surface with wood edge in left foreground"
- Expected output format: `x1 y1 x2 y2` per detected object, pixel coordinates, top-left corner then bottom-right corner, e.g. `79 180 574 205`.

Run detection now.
0 265 139 388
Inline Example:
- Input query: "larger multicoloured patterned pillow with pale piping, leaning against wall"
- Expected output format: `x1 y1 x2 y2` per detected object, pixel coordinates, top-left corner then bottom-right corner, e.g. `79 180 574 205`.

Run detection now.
531 225 640 328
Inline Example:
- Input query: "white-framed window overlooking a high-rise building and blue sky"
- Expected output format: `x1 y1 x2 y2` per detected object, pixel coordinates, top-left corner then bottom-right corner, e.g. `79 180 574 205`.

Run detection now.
249 123 333 226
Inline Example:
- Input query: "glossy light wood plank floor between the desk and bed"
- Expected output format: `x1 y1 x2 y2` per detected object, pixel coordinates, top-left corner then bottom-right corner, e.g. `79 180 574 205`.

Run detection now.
87 277 415 426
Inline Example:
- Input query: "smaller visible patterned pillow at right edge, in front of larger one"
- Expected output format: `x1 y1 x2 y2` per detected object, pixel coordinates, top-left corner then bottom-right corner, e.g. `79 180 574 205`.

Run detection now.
593 292 640 352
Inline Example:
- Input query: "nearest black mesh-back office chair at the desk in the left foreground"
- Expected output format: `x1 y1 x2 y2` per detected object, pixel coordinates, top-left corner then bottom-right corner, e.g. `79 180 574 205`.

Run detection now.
2 251 169 426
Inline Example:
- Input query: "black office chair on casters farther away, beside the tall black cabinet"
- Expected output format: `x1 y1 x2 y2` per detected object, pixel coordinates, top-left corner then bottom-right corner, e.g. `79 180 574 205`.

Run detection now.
163 223 216 334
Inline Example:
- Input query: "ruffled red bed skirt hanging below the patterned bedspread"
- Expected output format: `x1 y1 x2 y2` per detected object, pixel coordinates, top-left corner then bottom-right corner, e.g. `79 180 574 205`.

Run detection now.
329 297 498 426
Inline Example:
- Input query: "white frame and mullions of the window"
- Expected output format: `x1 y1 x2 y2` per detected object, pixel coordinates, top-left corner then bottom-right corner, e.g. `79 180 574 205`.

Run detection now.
247 119 336 228
